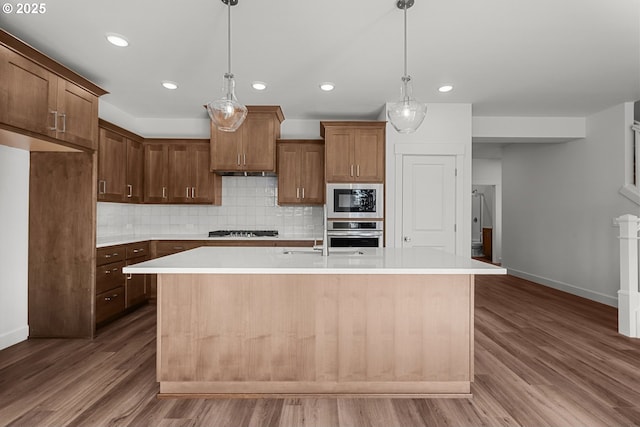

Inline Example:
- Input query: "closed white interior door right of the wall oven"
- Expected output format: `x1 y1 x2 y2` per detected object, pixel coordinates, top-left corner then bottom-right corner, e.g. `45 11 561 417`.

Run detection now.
402 155 456 253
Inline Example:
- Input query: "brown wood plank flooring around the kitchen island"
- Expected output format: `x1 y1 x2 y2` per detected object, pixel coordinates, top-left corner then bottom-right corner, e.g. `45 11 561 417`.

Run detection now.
0 276 640 427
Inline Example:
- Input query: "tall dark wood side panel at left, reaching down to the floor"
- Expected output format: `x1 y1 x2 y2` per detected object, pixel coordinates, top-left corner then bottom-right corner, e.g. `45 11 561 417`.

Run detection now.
29 152 97 338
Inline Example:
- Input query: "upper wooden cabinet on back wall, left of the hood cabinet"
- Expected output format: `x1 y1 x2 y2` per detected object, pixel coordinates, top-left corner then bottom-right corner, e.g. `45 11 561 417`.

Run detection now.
144 139 222 205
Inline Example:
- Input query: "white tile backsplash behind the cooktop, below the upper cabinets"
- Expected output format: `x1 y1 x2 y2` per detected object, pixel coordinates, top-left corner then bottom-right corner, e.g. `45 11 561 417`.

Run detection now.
97 176 322 238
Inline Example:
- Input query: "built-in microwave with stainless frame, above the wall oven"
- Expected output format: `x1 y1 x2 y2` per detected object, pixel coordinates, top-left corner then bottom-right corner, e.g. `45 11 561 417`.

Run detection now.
326 183 384 219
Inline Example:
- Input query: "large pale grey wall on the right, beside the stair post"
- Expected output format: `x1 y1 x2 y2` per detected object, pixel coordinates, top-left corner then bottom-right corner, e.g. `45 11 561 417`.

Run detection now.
502 103 638 306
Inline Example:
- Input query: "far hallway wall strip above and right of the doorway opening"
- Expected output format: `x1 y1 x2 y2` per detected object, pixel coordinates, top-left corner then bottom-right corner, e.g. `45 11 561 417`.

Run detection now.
472 158 502 263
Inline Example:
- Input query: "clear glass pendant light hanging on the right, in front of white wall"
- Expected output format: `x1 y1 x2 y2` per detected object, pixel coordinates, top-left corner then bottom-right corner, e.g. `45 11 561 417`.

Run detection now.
387 0 427 133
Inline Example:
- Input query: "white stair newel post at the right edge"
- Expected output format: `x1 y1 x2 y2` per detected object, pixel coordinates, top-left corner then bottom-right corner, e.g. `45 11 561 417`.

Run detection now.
616 215 640 338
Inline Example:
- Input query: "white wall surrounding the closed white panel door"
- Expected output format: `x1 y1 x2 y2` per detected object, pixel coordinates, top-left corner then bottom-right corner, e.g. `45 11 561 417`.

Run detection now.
382 104 471 256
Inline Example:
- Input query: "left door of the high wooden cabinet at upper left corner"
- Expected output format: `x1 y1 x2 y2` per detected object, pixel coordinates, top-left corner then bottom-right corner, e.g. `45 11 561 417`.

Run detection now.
0 46 58 136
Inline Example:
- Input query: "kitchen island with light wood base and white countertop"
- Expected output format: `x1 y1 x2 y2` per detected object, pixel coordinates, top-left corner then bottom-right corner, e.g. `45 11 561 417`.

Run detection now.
123 247 506 397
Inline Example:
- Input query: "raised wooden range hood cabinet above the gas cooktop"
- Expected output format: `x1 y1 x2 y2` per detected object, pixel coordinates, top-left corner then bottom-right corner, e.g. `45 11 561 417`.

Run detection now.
211 105 284 172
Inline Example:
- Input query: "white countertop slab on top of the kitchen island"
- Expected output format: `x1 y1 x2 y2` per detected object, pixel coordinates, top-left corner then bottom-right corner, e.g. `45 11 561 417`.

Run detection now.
122 247 507 274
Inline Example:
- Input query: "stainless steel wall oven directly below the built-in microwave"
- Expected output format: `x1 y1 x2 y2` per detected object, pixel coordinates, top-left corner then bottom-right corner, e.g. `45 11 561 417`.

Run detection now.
327 220 384 248
